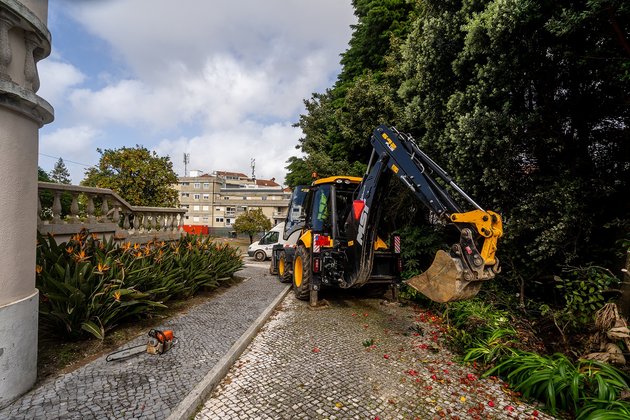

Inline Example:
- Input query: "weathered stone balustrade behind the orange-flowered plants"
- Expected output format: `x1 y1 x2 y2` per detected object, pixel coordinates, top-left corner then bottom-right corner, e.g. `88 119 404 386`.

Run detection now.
37 182 186 243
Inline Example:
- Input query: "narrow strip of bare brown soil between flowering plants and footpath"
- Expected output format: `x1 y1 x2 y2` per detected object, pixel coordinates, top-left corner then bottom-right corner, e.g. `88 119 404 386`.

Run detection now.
35 277 243 386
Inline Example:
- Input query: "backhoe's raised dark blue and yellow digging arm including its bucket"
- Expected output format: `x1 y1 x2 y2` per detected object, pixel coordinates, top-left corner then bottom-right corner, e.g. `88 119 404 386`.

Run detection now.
347 125 503 302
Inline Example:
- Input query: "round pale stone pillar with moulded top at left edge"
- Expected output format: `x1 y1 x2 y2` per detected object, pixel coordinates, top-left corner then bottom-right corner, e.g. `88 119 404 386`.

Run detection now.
0 0 53 407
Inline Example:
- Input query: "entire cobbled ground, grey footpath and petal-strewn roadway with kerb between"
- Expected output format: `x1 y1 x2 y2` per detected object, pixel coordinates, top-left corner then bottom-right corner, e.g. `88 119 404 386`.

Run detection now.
0 259 550 419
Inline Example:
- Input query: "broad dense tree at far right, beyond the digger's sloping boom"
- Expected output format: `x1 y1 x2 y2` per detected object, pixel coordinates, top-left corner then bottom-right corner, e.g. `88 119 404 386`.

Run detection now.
401 0 630 286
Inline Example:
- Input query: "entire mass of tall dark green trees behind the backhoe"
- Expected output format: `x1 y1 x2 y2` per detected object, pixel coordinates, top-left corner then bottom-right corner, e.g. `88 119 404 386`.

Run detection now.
286 0 630 300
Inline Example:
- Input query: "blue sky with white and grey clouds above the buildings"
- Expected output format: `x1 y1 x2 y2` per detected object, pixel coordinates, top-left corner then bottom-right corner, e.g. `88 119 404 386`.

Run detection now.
38 0 356 183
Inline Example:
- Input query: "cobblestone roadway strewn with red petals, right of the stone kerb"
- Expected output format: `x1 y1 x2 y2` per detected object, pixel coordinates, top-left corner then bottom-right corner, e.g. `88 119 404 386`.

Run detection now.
196 293 551 420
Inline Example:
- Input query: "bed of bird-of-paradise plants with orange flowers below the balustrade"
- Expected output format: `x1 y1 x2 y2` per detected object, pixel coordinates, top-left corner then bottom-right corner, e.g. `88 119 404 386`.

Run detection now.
36 231 243 339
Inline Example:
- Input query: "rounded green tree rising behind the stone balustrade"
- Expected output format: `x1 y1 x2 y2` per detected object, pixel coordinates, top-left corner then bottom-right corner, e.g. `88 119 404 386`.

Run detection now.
81 145 179 207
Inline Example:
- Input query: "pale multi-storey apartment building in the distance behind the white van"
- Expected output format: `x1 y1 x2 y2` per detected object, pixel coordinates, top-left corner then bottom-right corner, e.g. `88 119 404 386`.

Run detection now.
175 171 291 236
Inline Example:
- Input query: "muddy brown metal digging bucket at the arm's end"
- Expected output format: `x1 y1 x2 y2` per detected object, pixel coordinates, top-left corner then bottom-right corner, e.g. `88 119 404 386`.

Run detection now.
407 250 483 303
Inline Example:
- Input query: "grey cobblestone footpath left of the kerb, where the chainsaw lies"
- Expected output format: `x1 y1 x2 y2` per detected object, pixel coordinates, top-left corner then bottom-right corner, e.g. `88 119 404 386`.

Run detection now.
0 264 284 419
